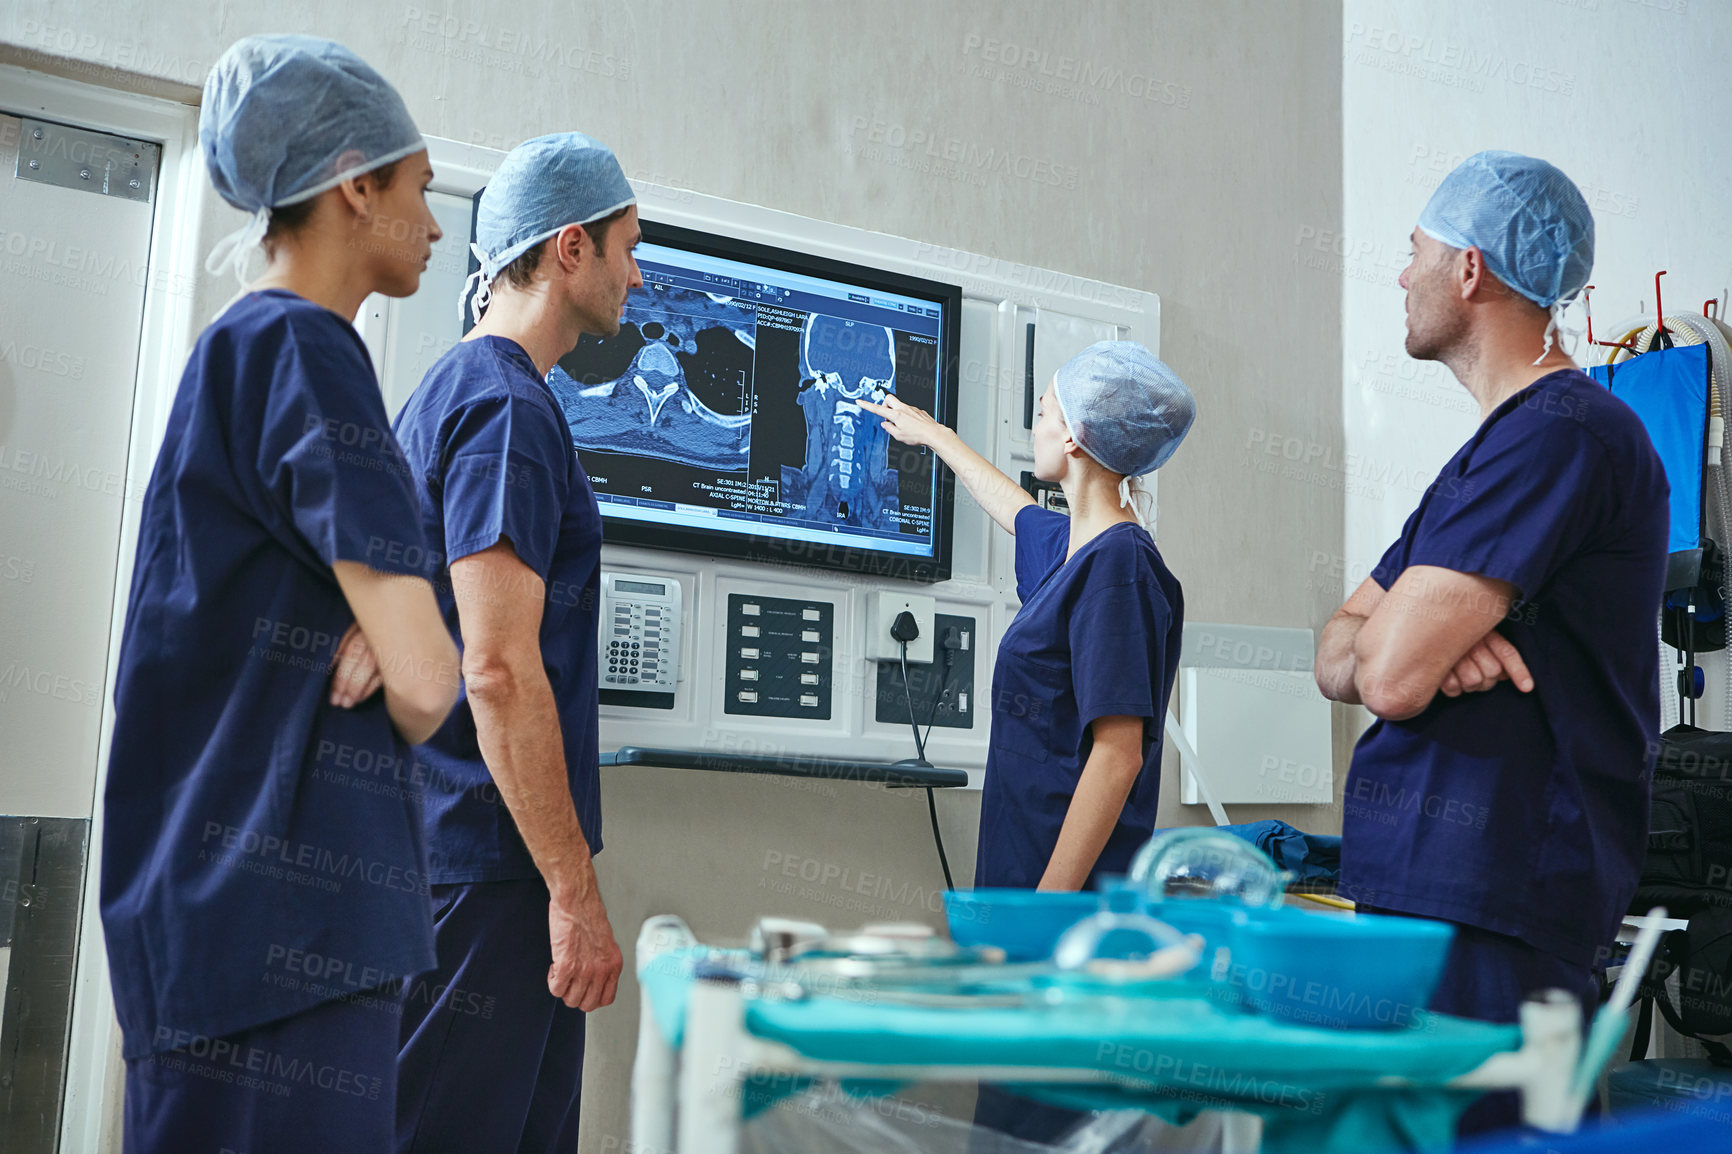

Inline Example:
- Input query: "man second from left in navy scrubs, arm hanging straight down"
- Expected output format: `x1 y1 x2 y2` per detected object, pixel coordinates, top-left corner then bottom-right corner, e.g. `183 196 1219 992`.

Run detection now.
397 132 643 1154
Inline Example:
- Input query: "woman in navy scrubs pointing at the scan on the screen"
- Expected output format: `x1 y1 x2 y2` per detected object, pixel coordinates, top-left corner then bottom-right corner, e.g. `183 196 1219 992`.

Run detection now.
859 341 1195 1140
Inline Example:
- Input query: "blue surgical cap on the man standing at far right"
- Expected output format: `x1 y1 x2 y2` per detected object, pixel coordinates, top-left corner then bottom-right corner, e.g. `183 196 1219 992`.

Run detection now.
1419 151 1593 308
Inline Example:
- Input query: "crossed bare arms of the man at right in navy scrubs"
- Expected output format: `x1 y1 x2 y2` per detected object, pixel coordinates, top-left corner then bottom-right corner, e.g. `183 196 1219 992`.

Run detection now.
1316 565 1533 721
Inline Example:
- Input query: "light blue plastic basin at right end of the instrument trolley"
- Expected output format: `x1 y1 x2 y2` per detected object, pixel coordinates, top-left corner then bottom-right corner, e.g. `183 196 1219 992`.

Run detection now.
1223 908 1455 1029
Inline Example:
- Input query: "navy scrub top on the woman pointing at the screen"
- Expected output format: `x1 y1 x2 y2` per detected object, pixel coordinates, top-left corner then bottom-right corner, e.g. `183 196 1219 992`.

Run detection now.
975 506 1185 887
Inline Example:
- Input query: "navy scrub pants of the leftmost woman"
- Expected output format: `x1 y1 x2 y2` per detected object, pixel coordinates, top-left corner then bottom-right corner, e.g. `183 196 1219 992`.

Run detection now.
121 989 398 1154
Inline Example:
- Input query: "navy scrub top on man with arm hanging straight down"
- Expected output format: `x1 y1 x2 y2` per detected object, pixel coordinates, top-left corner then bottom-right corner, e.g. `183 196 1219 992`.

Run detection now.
397 336 601 884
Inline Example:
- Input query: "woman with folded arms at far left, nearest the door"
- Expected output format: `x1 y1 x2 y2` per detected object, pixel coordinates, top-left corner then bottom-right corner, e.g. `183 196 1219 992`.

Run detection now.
100 36 457 1154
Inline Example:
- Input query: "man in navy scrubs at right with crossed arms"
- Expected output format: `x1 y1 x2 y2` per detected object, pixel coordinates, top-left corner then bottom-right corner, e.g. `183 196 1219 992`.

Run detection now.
1316 152 1668 1133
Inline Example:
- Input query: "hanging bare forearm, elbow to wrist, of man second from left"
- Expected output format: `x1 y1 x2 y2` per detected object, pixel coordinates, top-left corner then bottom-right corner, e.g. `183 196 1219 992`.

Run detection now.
469 669 596 908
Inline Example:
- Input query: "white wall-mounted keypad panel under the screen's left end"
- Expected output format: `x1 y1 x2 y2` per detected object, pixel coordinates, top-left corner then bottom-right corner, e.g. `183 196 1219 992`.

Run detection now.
596 572 681 709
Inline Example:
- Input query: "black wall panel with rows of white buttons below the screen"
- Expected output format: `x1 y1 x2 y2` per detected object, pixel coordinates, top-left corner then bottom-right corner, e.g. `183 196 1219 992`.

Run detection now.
722 593 837 721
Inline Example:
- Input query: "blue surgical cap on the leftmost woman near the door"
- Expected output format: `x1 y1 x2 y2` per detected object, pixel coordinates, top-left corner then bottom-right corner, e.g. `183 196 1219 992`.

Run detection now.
199 36 426 272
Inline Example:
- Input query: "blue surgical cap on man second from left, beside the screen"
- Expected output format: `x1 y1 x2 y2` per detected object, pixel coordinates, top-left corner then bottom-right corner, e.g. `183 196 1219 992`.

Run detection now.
459 132 637 319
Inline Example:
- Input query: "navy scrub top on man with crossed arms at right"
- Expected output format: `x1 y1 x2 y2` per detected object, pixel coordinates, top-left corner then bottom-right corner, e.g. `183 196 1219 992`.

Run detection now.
1341 371 1668 965
